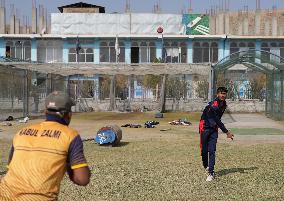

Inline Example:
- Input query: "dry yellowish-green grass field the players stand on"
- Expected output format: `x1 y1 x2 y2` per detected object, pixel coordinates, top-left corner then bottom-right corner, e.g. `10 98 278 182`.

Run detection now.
0 113 284 201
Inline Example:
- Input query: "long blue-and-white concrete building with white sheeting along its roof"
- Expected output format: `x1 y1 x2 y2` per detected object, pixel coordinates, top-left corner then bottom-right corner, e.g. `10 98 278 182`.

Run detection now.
0 2 284 98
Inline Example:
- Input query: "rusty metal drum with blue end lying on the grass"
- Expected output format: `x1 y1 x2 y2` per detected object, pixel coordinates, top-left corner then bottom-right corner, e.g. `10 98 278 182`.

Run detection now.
95 125 122 146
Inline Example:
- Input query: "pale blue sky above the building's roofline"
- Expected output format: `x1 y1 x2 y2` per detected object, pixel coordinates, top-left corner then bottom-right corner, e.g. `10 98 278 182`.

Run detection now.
5 0 284 18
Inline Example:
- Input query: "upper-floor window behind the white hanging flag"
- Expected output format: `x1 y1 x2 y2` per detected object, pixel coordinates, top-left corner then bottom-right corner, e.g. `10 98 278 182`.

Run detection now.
100 41 125 63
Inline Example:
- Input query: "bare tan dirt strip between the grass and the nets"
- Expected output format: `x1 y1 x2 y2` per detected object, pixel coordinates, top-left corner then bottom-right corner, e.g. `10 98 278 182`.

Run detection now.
0 113 284 145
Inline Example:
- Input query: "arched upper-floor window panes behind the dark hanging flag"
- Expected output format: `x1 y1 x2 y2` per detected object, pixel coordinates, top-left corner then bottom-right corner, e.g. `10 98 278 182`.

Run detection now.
68 48 94 63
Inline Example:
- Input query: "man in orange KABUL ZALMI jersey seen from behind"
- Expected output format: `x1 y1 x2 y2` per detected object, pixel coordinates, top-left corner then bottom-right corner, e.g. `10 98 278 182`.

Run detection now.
0 91 90 201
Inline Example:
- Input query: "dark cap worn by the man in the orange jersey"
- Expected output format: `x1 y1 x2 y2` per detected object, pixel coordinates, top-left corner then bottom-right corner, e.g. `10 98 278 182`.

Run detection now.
45 91 75 112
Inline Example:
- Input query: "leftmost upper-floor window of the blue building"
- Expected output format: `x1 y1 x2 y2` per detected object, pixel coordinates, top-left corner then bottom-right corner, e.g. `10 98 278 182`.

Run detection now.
6 40 31 61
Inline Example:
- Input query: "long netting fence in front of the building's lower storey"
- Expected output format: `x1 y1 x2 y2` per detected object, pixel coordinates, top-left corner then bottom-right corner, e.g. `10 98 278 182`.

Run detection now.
0 61 276 120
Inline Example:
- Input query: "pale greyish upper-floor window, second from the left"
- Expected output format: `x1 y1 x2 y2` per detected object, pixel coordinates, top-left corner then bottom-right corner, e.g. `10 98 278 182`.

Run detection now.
37 40 62 63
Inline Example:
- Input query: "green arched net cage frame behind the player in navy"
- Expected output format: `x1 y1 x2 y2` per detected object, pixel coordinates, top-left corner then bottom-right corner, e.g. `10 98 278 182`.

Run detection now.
214 49 284 120
